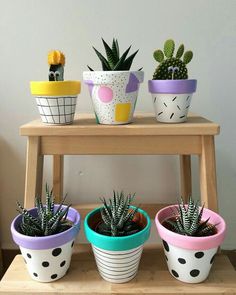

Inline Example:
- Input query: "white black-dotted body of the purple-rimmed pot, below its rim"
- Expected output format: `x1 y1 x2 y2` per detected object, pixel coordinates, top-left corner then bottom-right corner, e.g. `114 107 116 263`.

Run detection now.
20 241 74 282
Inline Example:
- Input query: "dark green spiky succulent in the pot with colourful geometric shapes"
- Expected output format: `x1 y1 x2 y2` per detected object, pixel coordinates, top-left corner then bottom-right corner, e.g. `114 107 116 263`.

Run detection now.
88 38 141 71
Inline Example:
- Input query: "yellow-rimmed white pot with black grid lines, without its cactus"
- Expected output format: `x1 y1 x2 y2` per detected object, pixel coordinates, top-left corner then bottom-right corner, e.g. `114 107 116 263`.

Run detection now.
30 81 80 125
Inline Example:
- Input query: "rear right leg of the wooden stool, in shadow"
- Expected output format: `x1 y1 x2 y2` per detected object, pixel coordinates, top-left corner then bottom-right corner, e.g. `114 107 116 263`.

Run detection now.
180 155 192 203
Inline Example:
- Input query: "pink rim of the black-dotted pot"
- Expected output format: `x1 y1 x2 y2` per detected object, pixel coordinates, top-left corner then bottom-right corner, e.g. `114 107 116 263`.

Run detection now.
155 205 226 250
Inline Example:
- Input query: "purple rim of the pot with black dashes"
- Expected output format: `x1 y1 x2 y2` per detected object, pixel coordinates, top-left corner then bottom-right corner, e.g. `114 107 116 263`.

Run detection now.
148 79 197 94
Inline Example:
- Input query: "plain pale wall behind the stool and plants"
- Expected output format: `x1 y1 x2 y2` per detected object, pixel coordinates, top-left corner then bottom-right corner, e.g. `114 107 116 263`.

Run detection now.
0 0 236 249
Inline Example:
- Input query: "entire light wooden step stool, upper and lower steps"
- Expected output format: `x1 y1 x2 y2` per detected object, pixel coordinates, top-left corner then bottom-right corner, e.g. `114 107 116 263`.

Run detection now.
0 114 236 295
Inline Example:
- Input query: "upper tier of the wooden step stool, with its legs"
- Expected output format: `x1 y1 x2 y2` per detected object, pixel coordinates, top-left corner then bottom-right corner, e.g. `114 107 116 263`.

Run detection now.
20 114 219 215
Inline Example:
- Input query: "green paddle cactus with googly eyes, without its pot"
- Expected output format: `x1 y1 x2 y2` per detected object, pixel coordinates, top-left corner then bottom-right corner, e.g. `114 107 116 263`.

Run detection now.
153 39 193 80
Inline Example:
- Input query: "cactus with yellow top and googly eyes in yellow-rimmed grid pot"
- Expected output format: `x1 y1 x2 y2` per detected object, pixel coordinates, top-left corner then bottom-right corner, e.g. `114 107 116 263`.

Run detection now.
30 50 80 125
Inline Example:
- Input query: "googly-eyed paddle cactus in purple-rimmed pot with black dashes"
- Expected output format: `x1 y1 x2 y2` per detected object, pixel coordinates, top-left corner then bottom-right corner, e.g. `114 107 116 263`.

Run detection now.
148 39 197 123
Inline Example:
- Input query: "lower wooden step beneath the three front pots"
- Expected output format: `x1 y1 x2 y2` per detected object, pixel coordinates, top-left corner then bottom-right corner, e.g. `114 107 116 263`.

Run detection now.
0 245 236 295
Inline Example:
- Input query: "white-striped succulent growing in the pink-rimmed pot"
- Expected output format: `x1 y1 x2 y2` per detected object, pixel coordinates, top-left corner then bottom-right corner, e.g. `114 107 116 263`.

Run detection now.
165 197 216 237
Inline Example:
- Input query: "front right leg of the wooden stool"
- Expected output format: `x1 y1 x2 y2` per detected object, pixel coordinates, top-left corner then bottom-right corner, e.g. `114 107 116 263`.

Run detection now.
200 136 218 212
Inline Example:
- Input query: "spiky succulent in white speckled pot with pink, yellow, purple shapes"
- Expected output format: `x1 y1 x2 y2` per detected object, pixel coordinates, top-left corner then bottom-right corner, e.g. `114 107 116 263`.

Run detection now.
83 39 144 125
